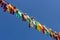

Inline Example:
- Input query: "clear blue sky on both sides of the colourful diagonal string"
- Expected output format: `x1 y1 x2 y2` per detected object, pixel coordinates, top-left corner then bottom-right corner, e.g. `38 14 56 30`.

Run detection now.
0 0 60 40
